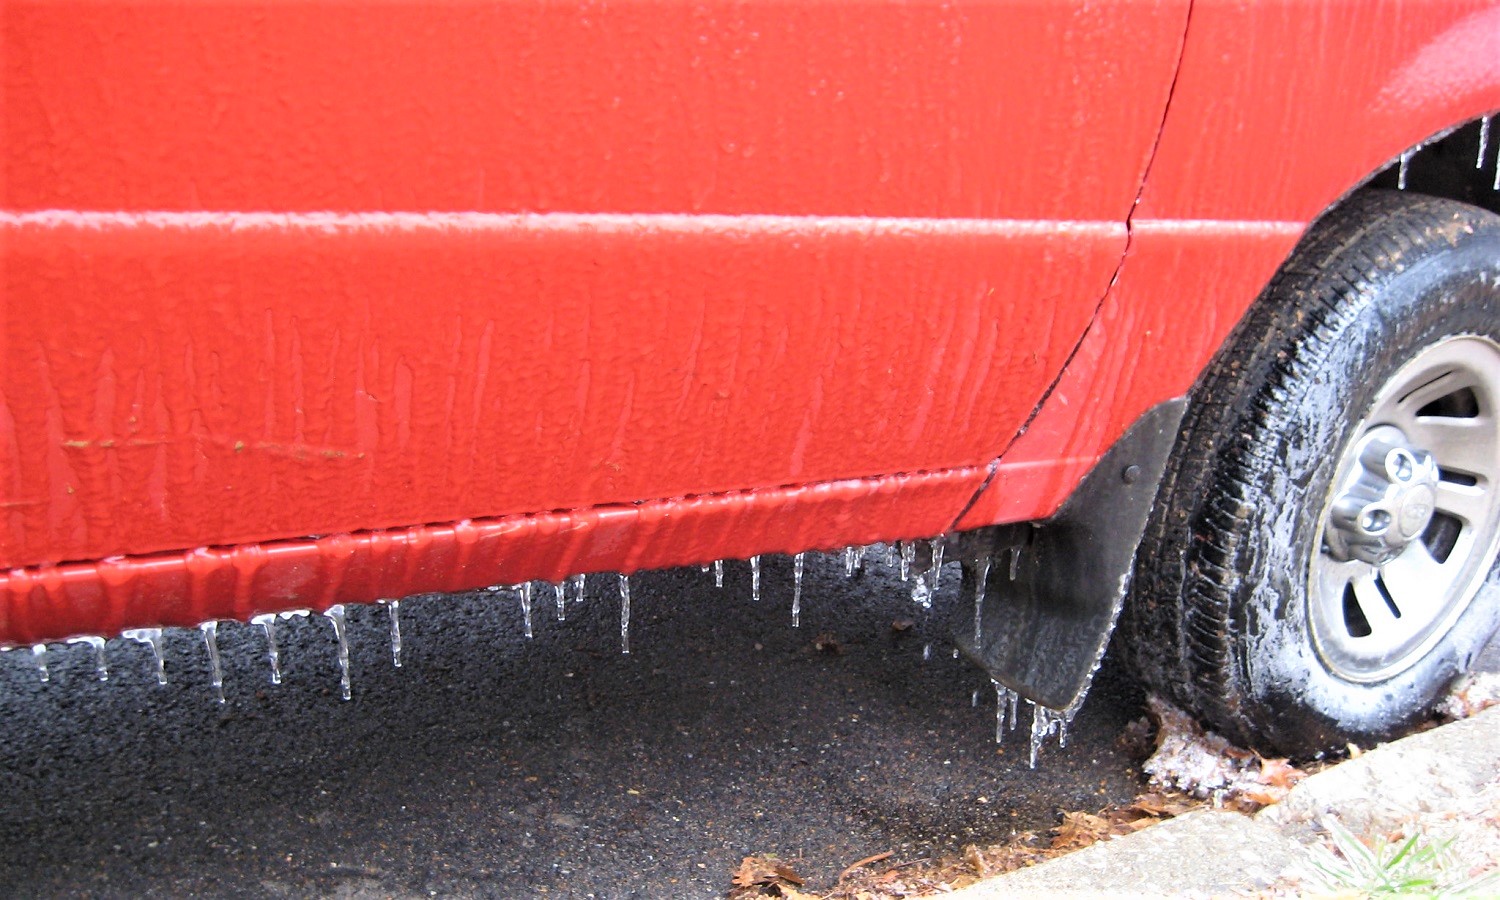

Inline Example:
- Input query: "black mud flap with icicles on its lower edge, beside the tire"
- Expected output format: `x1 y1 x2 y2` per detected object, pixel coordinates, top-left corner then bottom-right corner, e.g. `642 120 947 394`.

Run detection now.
950 398 1187 717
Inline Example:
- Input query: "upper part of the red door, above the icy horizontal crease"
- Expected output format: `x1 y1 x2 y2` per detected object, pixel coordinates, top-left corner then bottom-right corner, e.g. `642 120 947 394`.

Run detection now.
0 0 1187 221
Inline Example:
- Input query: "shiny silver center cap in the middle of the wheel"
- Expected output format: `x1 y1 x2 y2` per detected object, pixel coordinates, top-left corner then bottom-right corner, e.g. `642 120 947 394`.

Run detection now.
1323 425 1439 566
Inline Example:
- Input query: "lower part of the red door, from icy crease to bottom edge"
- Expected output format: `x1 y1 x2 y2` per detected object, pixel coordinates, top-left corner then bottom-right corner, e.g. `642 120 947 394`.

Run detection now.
0 213 1124 566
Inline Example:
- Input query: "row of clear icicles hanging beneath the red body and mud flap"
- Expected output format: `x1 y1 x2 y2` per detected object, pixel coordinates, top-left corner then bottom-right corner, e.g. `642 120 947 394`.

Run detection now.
6 537 1076 768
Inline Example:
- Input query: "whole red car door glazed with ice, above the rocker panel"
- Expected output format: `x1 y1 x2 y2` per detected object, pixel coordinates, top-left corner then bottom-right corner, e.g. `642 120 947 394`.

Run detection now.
0 0 1187 585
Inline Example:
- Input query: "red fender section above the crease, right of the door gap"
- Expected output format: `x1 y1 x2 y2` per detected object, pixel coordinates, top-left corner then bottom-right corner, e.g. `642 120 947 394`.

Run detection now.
1137 0 1500 222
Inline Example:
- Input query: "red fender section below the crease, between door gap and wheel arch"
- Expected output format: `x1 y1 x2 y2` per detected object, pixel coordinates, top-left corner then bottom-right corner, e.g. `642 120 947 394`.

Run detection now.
959 219 1304 528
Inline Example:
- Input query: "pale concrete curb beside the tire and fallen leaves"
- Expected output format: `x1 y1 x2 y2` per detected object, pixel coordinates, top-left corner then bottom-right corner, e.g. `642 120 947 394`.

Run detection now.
953 708 1500 900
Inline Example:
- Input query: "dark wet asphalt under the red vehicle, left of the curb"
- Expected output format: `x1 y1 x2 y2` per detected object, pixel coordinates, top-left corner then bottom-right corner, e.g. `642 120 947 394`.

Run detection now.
0 555 1142 897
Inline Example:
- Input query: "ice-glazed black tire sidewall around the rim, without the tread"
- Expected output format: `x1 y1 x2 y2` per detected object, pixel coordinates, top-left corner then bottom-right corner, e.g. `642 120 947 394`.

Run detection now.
1230 233 1500 753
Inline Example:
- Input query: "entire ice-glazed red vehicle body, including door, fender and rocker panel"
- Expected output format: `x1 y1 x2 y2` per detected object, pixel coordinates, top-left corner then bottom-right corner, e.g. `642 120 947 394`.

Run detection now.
0 0 1500 711
